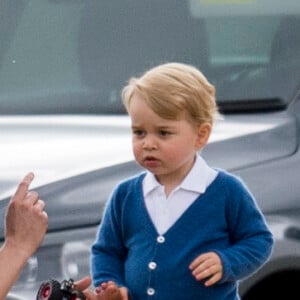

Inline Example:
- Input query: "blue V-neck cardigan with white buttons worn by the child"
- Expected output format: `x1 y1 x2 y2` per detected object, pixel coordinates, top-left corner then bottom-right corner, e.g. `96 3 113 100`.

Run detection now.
91 170 273 300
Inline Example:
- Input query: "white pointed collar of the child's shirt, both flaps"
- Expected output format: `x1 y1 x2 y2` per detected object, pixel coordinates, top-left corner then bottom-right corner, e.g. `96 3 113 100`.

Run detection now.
143 154 216 196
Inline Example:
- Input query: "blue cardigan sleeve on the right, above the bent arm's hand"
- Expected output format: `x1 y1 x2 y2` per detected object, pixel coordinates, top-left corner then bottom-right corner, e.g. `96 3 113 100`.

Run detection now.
216 173 274 283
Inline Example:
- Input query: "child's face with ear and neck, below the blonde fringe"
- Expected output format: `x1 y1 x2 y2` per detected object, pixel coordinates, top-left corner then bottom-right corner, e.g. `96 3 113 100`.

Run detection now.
128 95 211 184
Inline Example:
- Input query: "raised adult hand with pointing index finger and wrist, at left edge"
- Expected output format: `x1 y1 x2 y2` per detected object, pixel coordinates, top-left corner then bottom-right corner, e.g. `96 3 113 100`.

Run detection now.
0 173 48 300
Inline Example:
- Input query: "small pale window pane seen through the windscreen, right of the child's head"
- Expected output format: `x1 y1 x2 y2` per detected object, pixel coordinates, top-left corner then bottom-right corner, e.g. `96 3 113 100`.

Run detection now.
206 17 279 67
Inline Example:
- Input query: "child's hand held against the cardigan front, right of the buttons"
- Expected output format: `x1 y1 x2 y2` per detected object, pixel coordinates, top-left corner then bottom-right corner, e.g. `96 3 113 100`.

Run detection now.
189 252 223 286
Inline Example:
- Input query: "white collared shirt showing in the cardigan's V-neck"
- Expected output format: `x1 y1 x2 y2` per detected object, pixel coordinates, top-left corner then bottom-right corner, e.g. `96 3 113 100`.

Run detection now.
143 155 218 234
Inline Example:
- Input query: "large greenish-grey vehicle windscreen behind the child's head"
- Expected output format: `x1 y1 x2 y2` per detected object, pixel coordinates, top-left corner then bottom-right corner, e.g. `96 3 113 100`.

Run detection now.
0 0 300 114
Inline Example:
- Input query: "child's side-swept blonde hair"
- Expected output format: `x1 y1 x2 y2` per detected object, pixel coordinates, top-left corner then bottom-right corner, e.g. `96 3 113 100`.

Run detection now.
122 62 218 125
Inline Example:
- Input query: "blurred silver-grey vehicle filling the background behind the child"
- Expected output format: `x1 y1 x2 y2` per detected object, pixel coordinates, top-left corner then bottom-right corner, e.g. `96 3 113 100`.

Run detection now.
0 0 300 300
